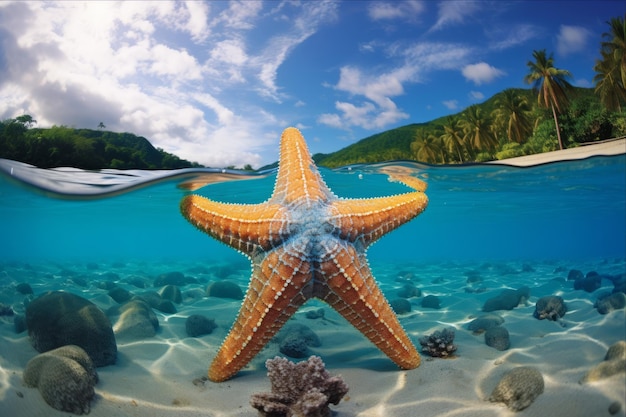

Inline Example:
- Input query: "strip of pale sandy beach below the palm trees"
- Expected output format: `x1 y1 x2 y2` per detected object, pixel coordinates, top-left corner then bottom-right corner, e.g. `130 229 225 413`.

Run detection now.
487 138 626 167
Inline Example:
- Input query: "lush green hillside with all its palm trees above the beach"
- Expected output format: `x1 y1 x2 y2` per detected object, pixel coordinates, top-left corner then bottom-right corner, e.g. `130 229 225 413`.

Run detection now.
314 18 626 167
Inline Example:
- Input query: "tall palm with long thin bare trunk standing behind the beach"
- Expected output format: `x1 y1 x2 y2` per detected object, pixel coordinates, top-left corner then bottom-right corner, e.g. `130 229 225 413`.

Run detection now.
524 49 573 149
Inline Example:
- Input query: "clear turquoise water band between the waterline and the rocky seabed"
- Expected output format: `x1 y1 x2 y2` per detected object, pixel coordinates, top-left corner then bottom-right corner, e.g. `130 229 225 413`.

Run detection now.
0 155 626 263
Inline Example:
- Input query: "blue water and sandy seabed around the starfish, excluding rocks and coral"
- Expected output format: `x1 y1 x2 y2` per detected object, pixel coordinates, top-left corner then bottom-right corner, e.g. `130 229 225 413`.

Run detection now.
0 154 626 417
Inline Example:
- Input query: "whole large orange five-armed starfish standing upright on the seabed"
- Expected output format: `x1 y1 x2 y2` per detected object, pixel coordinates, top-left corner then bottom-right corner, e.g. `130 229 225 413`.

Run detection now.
181 128 428 382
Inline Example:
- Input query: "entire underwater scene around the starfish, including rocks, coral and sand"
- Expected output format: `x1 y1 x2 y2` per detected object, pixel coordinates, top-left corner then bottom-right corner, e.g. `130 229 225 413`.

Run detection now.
0 154 626 417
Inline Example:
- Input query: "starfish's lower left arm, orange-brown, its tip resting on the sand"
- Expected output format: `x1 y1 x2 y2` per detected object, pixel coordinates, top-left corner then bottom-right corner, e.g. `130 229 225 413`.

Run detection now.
209 248 311 382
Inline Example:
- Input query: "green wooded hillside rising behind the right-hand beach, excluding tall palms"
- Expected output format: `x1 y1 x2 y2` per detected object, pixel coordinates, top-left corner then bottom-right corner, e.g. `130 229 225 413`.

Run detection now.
314 88 626 168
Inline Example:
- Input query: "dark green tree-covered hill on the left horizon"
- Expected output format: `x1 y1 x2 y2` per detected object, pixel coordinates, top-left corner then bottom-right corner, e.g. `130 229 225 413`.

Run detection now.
0 115 200 169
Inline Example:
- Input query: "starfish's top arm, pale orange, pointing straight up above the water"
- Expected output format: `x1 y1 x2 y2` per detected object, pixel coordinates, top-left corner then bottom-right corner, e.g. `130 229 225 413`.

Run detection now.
270 127 336 204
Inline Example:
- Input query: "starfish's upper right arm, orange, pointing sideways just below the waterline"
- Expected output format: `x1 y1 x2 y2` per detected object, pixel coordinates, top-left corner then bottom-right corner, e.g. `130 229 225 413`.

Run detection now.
330 191 428 247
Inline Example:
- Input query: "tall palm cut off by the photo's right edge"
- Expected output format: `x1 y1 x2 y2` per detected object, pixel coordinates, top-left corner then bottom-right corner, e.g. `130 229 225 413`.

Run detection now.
593 17 626 111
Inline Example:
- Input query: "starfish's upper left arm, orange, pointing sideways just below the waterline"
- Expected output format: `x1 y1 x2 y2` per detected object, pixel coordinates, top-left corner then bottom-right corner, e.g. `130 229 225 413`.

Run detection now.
180 195 287 254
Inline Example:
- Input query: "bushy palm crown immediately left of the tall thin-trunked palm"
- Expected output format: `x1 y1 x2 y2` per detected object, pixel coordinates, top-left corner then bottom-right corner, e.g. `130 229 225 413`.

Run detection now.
493 88 533 143
